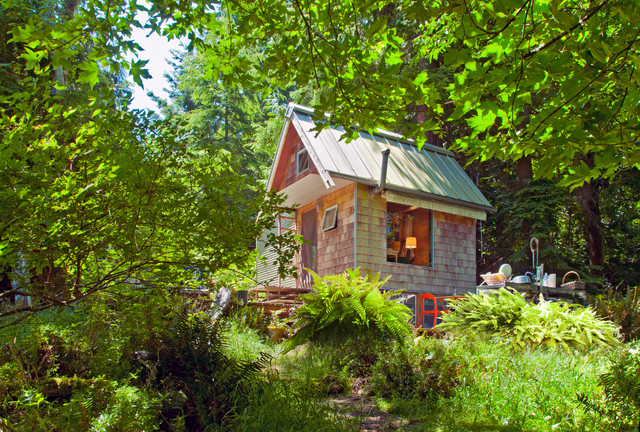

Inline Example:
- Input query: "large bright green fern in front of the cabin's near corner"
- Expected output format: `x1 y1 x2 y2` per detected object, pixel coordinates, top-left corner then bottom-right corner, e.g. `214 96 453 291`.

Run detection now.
287 269 411 350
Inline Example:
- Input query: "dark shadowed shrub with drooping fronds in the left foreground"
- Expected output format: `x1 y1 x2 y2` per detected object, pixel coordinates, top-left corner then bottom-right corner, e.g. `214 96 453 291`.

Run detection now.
140 311 270 430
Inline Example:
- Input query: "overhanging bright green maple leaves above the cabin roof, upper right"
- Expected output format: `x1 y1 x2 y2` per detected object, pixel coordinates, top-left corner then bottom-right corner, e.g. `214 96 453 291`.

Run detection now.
205 0 640 186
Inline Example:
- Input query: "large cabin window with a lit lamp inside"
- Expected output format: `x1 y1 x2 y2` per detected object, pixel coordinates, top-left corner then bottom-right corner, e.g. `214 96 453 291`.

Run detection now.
387 203 433 266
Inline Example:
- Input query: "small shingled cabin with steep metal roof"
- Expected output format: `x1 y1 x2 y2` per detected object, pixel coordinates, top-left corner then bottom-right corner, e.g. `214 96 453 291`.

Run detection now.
257 104 492 324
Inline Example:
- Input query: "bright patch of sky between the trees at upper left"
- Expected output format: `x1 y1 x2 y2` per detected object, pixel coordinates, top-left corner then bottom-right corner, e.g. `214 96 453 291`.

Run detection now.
126 23 181 112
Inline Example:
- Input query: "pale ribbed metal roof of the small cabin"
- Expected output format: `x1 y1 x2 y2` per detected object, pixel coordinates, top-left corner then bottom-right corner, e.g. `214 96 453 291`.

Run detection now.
291 108 491 208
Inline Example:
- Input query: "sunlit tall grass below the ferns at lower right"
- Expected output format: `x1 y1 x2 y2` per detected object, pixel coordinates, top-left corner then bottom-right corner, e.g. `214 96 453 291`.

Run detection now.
382 335 608 432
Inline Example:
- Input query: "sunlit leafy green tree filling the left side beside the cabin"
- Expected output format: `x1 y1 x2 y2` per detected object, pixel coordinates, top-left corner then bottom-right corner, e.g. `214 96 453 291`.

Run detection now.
0 1 296 316
